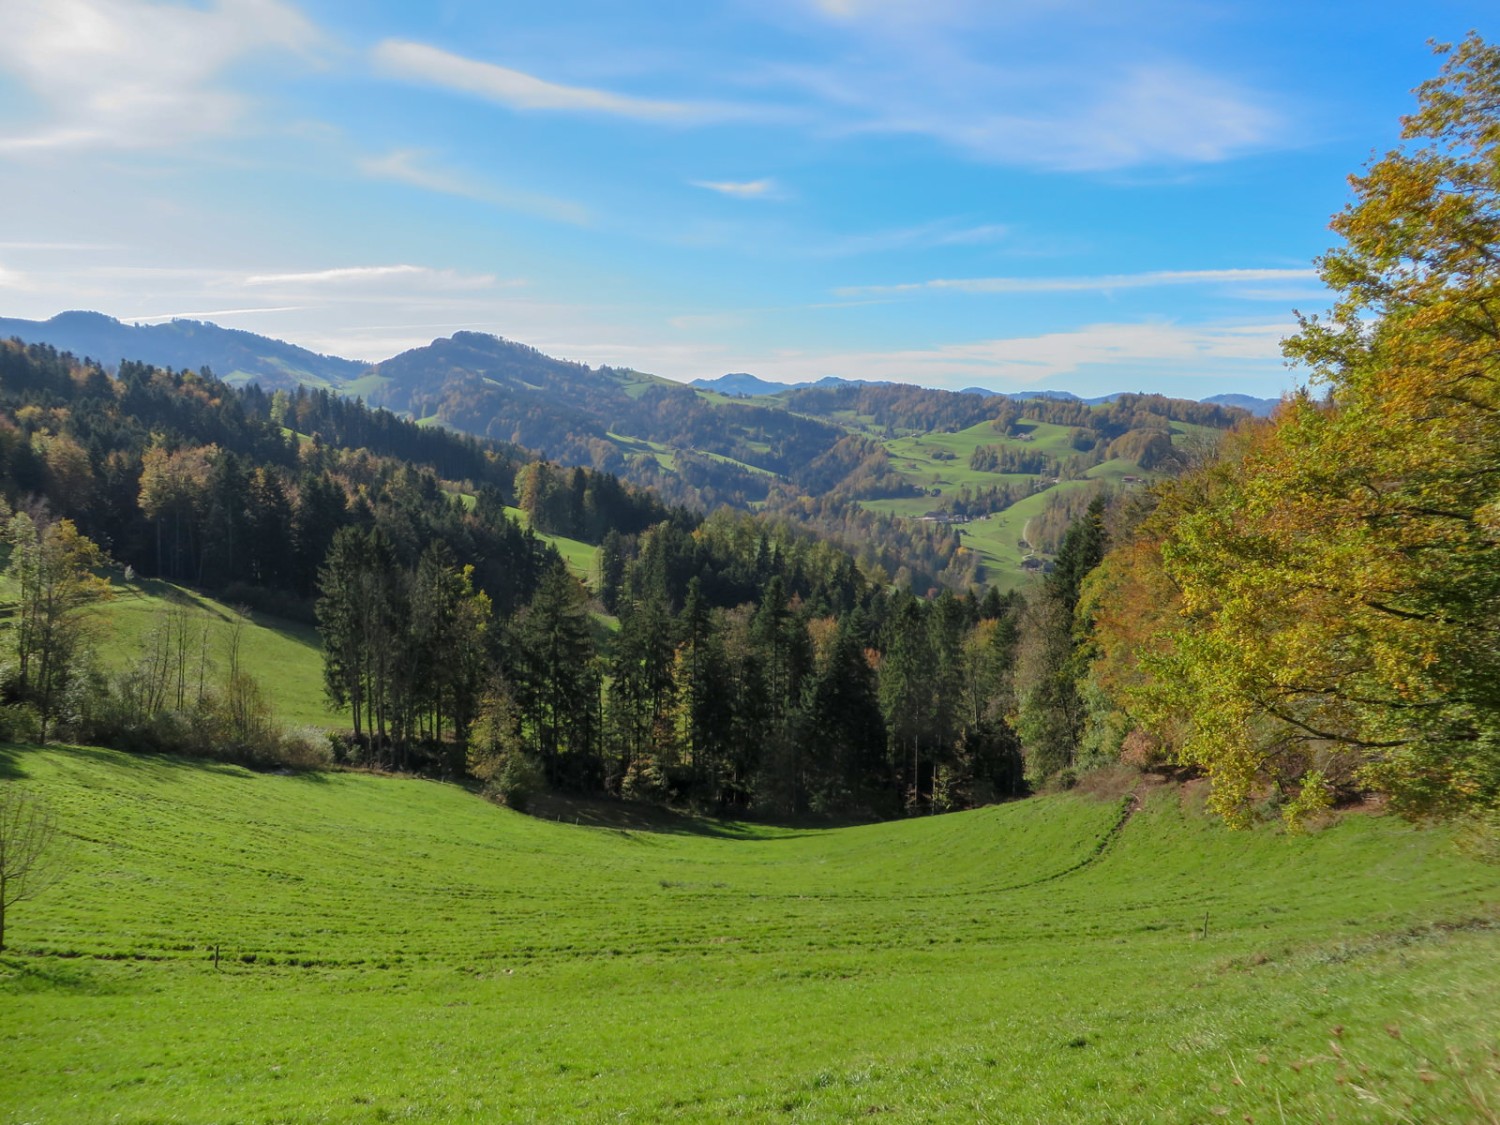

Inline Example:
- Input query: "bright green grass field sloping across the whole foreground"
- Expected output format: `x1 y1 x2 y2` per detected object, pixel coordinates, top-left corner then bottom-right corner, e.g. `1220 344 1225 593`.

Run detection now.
0 747 1500 1125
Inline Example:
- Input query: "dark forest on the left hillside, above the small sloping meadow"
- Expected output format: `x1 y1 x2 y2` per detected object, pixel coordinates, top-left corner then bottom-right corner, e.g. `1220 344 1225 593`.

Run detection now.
0 341 690 620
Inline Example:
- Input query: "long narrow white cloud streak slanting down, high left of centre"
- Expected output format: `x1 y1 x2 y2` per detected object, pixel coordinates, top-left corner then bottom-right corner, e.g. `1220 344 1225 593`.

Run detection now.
374 39 747 123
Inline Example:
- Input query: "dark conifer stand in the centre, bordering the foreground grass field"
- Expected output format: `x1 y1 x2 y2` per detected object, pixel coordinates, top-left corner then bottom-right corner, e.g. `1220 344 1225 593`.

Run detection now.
318 512 1028 816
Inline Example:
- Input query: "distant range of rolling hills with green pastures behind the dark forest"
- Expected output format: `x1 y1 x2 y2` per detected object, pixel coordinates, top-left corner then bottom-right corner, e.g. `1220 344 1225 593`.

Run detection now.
0 312 1266 590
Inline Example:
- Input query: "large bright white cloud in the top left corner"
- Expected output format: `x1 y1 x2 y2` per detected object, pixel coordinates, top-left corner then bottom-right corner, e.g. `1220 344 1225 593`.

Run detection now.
0 0 320 155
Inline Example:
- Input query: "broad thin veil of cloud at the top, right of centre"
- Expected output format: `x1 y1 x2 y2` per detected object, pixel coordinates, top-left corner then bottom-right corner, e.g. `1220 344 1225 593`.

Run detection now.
771 0 1296 173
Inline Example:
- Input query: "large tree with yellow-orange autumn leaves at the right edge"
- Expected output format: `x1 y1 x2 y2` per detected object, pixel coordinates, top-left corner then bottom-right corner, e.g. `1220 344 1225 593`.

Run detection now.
1095 36 1500 821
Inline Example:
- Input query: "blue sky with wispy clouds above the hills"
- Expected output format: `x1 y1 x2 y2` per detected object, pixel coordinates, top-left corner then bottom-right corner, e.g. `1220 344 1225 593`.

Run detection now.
0 0 1494 398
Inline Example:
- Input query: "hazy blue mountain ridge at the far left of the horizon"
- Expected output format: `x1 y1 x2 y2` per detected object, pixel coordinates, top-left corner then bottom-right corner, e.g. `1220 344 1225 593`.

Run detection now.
0 312 369 390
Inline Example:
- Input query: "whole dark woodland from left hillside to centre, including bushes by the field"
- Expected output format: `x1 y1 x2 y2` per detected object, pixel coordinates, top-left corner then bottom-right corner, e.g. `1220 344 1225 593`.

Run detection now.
0 342 1068 815
